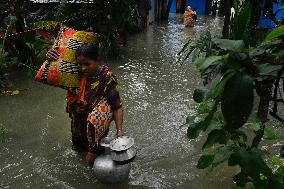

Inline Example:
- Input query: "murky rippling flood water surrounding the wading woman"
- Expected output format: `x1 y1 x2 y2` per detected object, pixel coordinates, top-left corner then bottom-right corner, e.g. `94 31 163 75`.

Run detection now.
0 15 239 189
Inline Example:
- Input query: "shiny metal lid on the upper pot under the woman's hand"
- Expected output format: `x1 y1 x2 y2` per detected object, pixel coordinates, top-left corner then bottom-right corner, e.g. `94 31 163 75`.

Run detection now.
110 136 134 151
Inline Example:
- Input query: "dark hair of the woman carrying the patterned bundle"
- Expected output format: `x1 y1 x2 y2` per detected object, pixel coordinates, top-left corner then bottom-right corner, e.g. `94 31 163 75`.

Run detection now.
75 45 99 60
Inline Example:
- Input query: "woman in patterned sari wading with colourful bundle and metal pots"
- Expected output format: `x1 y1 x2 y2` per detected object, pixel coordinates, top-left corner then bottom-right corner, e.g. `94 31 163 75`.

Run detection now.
47 45 123 166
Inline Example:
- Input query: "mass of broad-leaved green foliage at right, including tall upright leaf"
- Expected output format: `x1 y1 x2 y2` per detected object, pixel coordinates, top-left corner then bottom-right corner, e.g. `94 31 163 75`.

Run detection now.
178 1 284 189
